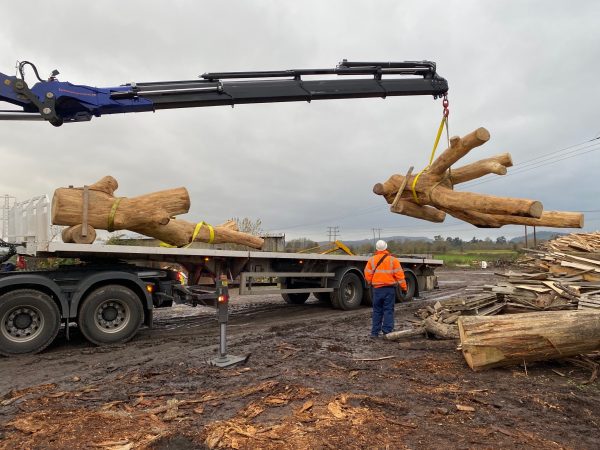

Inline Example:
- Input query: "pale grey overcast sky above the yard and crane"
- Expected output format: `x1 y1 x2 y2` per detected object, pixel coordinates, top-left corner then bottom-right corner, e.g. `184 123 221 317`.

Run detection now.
0 0 600 240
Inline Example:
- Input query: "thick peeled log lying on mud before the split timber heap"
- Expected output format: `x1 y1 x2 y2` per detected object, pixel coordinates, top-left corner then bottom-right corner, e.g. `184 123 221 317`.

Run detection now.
458 310 600 371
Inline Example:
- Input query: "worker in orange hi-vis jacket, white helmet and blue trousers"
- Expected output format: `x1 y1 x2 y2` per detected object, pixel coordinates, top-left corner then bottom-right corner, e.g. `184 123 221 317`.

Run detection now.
365 240 407 338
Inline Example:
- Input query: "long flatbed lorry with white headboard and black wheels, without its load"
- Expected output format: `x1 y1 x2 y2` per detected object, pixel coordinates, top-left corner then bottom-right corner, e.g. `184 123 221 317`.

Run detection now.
0 196 443 355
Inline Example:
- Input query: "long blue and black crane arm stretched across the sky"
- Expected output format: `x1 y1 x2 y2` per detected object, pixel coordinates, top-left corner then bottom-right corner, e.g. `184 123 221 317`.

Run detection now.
0 60 448 126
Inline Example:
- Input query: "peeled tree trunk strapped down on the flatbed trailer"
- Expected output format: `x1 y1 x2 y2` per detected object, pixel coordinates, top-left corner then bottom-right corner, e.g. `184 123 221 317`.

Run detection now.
52 176 264 248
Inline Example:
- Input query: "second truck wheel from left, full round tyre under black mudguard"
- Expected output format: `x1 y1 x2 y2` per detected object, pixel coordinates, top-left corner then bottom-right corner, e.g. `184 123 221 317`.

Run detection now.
78 284 144 345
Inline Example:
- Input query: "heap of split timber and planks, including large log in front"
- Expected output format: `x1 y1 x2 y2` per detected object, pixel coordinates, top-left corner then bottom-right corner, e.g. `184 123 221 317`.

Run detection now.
386 233 600 373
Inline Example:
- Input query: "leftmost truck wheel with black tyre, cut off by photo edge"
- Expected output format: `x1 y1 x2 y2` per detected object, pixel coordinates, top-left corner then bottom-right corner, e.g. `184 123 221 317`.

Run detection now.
0 289 60 356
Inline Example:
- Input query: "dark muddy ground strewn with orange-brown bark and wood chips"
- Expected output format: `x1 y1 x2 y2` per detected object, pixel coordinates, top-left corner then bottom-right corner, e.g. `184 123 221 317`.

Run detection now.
0 270 600 450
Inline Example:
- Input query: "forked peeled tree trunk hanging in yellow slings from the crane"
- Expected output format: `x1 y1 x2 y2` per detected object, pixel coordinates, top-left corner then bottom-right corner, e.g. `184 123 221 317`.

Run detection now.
373 128 583 228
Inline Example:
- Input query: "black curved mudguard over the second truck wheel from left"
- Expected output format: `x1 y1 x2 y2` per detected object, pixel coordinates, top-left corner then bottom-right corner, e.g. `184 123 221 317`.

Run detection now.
69 272 154 323
